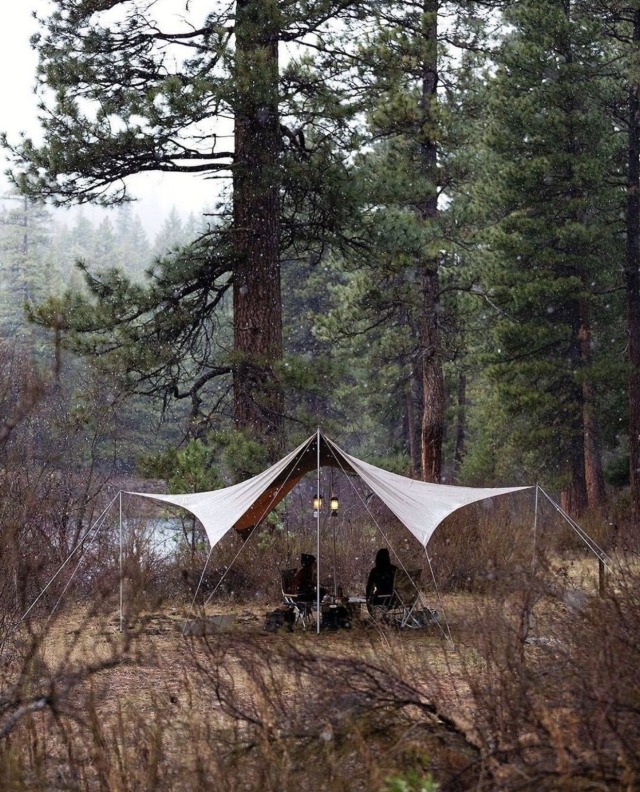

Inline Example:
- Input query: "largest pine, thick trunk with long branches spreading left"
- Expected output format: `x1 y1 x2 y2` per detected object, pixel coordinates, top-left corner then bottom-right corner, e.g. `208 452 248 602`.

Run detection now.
5 0 372 454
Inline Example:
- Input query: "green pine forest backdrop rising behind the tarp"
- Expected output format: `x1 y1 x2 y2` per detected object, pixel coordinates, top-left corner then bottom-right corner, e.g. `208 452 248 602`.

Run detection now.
0 0 640 524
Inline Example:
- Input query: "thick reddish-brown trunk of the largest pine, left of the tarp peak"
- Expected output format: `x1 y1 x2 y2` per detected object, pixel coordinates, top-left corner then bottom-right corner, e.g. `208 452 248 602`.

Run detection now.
233 0 284 454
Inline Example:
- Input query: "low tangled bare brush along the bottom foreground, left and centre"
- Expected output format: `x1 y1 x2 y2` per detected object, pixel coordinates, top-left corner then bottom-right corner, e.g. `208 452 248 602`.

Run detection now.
0 624 478 792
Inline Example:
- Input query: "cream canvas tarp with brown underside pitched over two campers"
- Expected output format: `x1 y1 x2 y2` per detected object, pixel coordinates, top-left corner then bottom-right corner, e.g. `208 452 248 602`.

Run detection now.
129 432 531 547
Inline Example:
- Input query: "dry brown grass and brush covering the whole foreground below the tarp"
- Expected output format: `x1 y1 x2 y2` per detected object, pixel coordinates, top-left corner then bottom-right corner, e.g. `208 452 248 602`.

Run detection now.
0 558 640 792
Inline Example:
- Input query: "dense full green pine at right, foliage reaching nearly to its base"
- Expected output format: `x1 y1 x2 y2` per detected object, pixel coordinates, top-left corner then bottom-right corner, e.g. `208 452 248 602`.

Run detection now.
477 0 620 512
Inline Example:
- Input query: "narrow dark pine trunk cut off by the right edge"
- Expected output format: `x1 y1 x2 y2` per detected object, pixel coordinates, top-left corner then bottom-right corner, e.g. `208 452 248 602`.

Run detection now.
625 10 640 529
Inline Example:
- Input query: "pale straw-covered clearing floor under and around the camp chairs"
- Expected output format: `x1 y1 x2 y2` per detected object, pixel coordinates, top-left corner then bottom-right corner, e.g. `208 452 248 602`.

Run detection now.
40 561 598 690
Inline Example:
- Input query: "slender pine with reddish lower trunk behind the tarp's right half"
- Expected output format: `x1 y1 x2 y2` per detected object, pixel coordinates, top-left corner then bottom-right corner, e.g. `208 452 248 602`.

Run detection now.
318 2 492 481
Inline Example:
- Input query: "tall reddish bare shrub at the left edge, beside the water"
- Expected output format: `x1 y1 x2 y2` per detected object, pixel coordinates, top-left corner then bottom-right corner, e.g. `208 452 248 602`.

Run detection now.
0 340 129 619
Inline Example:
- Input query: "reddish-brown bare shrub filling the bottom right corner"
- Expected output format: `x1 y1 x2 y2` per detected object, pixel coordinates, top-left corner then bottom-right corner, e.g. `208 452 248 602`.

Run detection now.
458 560 640 790
